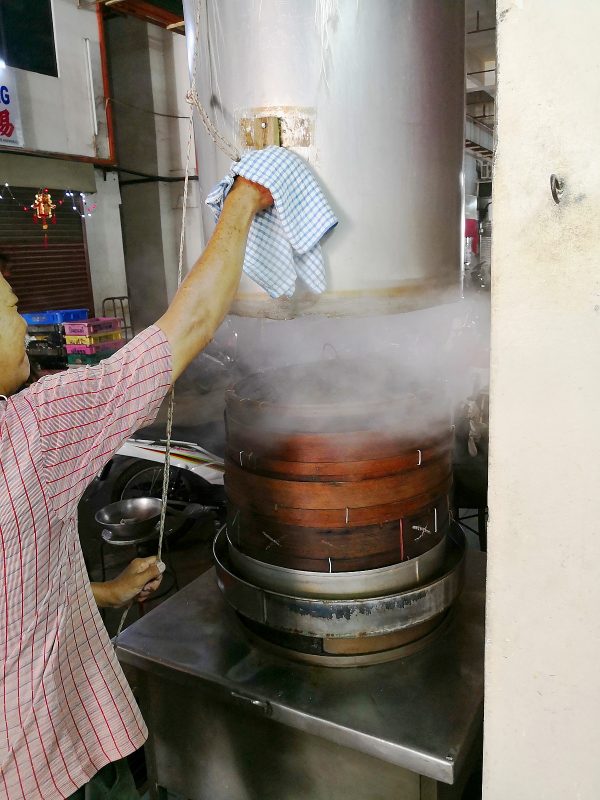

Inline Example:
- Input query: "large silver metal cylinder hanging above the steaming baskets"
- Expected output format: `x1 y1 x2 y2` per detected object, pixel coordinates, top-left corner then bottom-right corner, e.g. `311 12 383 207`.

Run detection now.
184 0 464 318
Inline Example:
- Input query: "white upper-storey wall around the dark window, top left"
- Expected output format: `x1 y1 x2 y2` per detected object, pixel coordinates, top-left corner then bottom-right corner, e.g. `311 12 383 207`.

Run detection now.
5 0 109 158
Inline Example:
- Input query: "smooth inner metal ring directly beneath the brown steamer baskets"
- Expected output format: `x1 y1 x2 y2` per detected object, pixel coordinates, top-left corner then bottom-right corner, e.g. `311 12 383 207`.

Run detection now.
227 535 446 600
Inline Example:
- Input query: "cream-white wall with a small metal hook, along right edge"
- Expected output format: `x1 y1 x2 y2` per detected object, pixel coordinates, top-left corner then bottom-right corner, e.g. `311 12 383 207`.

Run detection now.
484 0 600 800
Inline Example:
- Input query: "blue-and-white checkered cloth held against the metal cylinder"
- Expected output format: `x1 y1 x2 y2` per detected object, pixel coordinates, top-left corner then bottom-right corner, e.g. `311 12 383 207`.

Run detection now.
206 147 337 297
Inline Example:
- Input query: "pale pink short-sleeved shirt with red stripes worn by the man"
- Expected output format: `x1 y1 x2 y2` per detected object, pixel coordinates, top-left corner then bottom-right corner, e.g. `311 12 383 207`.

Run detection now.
0 326 171 800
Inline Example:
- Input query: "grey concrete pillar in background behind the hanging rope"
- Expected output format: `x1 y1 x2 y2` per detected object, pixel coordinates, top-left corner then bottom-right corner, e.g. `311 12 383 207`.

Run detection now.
107 16 204 330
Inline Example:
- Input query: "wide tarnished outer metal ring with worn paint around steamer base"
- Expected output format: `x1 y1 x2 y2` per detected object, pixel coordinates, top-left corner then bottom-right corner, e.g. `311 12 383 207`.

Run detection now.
213 525 465 639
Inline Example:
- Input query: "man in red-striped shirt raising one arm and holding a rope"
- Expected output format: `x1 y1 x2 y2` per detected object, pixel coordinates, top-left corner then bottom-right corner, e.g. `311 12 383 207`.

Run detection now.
0 178 272 800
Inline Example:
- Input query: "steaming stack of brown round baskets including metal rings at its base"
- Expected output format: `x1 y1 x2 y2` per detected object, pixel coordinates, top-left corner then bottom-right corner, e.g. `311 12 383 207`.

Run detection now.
215 361 464 666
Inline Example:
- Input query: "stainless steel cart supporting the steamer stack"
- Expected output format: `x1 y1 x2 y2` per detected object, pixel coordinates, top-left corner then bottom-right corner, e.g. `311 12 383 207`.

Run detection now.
118 551 485 800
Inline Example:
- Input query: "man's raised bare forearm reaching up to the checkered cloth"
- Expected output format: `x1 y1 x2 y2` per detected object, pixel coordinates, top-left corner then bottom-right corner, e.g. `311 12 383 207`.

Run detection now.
157 181 264 380
